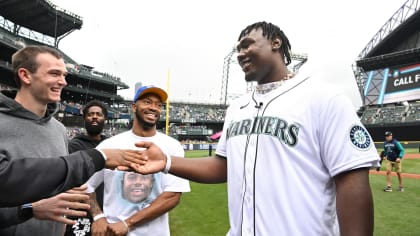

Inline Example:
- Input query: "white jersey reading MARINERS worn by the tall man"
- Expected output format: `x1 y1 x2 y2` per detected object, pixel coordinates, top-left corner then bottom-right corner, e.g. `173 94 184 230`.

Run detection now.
216 77 379 236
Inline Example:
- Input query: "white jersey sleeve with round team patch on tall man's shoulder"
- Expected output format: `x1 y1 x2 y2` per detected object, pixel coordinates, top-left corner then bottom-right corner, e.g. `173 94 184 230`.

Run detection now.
318 94 379 176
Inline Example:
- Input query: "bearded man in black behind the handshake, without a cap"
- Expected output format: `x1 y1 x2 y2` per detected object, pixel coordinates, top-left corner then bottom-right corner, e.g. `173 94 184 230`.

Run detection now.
65 100 108 236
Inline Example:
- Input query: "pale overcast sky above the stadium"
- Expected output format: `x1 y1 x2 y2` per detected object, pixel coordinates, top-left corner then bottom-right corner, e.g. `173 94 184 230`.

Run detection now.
53 0 405 108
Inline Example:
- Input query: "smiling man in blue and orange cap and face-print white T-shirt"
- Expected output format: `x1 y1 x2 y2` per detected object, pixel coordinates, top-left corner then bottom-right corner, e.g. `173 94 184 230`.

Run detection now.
88 86 190 236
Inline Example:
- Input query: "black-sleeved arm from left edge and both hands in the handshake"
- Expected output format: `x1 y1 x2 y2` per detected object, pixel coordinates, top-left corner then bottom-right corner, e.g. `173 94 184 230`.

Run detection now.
0 142 171 207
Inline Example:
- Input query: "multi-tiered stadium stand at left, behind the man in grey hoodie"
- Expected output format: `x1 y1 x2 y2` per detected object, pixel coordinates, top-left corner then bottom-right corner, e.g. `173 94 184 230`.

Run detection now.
0 0 129 129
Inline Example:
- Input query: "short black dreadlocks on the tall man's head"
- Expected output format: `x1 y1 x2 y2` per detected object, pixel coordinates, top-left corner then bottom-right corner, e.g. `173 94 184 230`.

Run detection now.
238 21 292 65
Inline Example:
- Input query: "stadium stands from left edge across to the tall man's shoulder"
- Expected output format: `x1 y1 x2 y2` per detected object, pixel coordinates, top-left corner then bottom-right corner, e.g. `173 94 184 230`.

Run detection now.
0 0 227 142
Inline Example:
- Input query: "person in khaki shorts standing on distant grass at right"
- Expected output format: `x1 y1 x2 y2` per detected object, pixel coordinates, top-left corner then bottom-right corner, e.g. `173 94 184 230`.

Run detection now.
384 131 404 192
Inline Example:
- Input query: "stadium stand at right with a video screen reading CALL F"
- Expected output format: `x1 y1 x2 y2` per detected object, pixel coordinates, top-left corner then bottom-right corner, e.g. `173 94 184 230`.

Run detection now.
353 0 420 141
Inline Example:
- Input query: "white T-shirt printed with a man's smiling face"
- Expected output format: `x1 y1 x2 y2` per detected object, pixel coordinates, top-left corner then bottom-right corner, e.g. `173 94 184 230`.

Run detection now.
88 130 190 236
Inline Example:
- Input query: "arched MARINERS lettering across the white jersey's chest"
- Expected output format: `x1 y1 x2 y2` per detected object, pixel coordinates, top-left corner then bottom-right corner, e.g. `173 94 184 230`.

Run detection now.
227 116 299 146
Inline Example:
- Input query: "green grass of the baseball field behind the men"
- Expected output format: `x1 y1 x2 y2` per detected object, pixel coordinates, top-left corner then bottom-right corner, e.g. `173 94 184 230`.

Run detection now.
170 150 420 236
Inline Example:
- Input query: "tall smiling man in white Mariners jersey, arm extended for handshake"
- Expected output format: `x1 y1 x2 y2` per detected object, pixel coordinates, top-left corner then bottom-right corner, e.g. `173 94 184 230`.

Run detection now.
133 22 379 236
